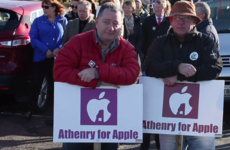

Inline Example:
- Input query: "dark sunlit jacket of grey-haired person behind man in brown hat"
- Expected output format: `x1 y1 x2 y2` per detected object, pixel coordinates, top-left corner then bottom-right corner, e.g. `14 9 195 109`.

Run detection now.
196 18 220 50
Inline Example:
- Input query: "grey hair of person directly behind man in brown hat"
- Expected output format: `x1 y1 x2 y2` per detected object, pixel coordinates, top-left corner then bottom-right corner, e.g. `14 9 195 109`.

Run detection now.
195 2 211 19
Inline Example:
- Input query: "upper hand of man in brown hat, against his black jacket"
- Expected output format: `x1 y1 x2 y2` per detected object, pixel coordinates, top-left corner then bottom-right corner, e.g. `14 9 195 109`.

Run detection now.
178 63 196 77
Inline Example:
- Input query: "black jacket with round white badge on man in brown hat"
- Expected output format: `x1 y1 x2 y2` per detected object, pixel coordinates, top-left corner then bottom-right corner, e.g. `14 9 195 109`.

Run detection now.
145 28 223 82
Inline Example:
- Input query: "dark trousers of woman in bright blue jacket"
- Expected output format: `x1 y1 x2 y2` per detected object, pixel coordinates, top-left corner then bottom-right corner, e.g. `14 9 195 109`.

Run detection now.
28 58 54 112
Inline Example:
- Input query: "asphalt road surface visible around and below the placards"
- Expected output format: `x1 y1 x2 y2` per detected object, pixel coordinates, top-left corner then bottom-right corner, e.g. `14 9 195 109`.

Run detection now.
0 96 230 150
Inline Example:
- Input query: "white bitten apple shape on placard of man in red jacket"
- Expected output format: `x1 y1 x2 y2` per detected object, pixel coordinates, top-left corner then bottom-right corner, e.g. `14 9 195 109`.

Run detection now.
87 92 111 122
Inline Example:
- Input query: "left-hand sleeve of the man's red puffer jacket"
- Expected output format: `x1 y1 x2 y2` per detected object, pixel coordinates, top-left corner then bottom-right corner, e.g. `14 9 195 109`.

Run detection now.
53 37 98 88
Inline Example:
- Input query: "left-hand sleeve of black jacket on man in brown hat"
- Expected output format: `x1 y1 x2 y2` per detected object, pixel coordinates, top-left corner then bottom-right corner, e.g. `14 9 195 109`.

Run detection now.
145 37 181 78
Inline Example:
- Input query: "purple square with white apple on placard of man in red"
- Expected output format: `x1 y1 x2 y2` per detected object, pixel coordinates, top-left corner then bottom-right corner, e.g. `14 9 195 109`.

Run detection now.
81 88 117 125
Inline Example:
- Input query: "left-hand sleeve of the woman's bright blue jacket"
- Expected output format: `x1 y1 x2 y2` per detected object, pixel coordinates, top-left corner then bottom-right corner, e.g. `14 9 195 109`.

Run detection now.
29 18 49 54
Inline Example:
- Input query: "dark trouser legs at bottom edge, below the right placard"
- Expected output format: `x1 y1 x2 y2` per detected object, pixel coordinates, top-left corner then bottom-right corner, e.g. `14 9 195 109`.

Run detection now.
141 133 160 150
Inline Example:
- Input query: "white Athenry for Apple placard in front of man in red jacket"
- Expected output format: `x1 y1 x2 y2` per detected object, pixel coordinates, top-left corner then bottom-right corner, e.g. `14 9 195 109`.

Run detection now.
53 82 143 143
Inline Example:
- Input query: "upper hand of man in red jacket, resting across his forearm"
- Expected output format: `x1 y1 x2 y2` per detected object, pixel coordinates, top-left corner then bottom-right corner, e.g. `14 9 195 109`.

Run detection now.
78 68 96 82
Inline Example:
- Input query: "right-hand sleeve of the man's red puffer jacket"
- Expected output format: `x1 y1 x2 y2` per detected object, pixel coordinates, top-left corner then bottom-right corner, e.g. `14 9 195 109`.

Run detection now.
98 43 140 85
